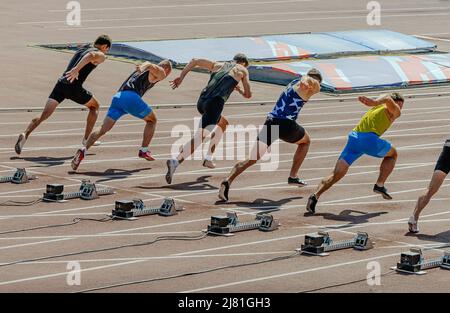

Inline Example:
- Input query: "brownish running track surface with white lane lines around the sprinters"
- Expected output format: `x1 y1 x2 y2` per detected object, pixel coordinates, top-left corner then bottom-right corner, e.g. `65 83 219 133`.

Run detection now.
0 0 450 293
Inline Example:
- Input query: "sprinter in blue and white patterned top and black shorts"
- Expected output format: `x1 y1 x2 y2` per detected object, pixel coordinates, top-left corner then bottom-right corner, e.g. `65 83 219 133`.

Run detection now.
219 69 322 201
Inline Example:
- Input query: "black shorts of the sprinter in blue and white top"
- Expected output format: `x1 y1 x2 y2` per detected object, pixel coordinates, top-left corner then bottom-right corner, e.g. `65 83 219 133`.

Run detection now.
258 117 305 146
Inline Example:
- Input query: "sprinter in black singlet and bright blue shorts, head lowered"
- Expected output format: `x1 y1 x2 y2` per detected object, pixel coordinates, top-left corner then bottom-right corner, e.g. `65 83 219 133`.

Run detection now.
72 60 172 171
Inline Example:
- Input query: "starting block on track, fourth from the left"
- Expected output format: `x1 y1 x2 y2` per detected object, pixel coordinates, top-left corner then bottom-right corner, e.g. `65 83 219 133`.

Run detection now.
204 212 280 236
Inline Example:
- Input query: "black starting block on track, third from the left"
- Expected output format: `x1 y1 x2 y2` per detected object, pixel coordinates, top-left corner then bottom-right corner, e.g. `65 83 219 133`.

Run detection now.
108 198 184 221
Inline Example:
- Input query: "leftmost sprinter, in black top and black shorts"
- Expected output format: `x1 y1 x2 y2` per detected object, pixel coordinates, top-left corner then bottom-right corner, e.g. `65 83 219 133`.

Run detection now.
15 35 111 154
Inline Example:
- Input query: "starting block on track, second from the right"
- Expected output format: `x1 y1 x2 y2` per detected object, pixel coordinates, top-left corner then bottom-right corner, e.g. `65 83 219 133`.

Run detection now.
296 232 373 256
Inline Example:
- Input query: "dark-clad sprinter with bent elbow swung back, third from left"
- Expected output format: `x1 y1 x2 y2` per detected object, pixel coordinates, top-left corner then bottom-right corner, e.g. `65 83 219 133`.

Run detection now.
166 53 252 184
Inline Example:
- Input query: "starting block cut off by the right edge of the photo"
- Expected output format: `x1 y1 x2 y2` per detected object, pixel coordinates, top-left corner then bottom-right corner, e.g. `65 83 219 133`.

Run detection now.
391 248 450 275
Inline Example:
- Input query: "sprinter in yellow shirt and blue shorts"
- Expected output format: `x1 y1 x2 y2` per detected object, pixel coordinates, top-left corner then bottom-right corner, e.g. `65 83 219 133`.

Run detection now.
306 92 405 214
